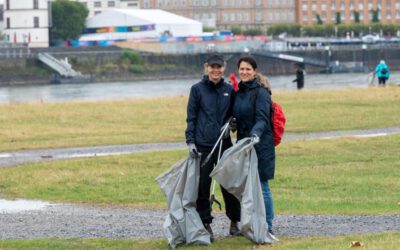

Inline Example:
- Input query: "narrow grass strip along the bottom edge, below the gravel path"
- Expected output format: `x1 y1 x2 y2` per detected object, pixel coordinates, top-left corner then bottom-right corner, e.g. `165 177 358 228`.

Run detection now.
0 233 400 250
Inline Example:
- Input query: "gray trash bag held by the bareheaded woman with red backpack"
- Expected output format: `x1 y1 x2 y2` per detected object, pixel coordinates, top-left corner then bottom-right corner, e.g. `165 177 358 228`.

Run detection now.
210 138 277 244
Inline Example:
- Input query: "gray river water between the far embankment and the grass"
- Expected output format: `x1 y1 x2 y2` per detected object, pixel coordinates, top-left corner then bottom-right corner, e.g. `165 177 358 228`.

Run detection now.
0 72 400 103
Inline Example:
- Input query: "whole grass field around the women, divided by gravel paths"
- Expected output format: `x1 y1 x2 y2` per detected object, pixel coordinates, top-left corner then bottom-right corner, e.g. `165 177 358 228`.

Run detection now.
0 87 400 250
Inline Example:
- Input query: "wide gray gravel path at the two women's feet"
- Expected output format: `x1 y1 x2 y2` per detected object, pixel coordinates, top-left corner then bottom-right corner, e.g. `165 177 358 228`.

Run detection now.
0 204 400 239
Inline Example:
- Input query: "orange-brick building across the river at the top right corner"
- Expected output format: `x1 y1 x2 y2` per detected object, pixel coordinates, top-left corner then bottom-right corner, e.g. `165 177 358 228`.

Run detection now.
296 0 400 25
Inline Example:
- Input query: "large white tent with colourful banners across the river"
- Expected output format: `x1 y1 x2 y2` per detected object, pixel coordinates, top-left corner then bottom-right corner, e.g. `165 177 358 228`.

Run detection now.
79 8 203 41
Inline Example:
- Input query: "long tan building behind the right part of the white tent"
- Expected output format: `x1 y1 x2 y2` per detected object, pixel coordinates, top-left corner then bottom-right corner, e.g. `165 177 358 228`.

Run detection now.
140 0 297 29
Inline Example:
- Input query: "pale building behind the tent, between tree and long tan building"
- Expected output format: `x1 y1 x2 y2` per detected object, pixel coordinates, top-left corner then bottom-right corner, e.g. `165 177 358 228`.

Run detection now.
72 0 140 17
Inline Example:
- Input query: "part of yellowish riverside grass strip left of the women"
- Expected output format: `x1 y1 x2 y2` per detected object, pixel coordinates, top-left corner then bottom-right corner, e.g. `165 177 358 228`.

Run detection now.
0 97 187 151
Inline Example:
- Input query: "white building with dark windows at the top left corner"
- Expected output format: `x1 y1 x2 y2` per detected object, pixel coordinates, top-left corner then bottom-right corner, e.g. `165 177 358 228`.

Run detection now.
3 0 49 47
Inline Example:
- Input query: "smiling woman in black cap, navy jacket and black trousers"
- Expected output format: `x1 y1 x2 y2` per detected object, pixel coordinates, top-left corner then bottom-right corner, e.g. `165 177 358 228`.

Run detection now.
186 54 240 241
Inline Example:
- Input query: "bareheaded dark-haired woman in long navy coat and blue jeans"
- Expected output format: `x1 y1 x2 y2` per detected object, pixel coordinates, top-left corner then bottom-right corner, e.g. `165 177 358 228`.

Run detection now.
233 57 275 234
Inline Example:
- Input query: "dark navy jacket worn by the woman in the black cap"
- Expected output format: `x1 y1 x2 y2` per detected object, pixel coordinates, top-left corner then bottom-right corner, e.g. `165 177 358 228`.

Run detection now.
186 76 234 147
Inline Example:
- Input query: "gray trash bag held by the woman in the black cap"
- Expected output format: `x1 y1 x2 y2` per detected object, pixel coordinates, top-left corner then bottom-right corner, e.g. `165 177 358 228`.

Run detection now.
156 157 211 248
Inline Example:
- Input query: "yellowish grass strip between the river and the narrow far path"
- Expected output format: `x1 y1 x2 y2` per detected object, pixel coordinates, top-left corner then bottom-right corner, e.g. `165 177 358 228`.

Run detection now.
0 87 400 151
